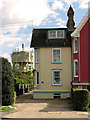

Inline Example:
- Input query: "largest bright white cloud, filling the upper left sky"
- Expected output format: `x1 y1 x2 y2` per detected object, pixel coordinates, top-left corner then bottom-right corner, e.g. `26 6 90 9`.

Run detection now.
0 0 57 47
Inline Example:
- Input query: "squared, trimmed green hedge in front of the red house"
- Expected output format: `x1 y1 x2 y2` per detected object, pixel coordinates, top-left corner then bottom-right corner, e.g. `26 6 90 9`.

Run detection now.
73 89 89 111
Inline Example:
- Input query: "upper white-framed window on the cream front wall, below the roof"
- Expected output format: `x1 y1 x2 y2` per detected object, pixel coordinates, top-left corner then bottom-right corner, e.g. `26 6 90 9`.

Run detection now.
52 48 61 63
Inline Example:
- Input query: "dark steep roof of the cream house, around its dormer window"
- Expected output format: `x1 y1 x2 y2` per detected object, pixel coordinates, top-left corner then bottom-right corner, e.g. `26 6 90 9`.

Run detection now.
30 28 71 48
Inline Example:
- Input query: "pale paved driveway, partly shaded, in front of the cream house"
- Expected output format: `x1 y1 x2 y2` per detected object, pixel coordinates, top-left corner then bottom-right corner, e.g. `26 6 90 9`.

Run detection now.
3 93 88 120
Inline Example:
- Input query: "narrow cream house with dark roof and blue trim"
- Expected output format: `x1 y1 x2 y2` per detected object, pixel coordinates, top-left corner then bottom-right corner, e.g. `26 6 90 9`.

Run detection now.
31 5 74 99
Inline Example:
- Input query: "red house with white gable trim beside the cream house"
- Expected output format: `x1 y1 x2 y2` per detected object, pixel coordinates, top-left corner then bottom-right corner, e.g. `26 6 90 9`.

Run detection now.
71 11 90 90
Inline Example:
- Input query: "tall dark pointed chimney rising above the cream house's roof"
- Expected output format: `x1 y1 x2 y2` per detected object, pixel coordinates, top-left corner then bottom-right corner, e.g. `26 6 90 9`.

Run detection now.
67 5 75 31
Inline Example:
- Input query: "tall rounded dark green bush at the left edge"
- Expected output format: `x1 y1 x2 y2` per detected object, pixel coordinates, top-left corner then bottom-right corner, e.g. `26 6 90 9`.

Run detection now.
0 58 14 106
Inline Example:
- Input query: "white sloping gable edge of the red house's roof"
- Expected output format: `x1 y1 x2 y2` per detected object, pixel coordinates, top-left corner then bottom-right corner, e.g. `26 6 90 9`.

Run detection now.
71 11 90 37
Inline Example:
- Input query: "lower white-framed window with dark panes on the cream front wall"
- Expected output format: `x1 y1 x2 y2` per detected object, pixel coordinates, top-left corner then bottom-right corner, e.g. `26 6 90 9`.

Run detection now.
52 70 62 85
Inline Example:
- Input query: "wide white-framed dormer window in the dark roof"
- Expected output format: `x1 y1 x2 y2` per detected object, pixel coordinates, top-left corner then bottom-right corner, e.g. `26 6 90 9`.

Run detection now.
48 30 65 39
